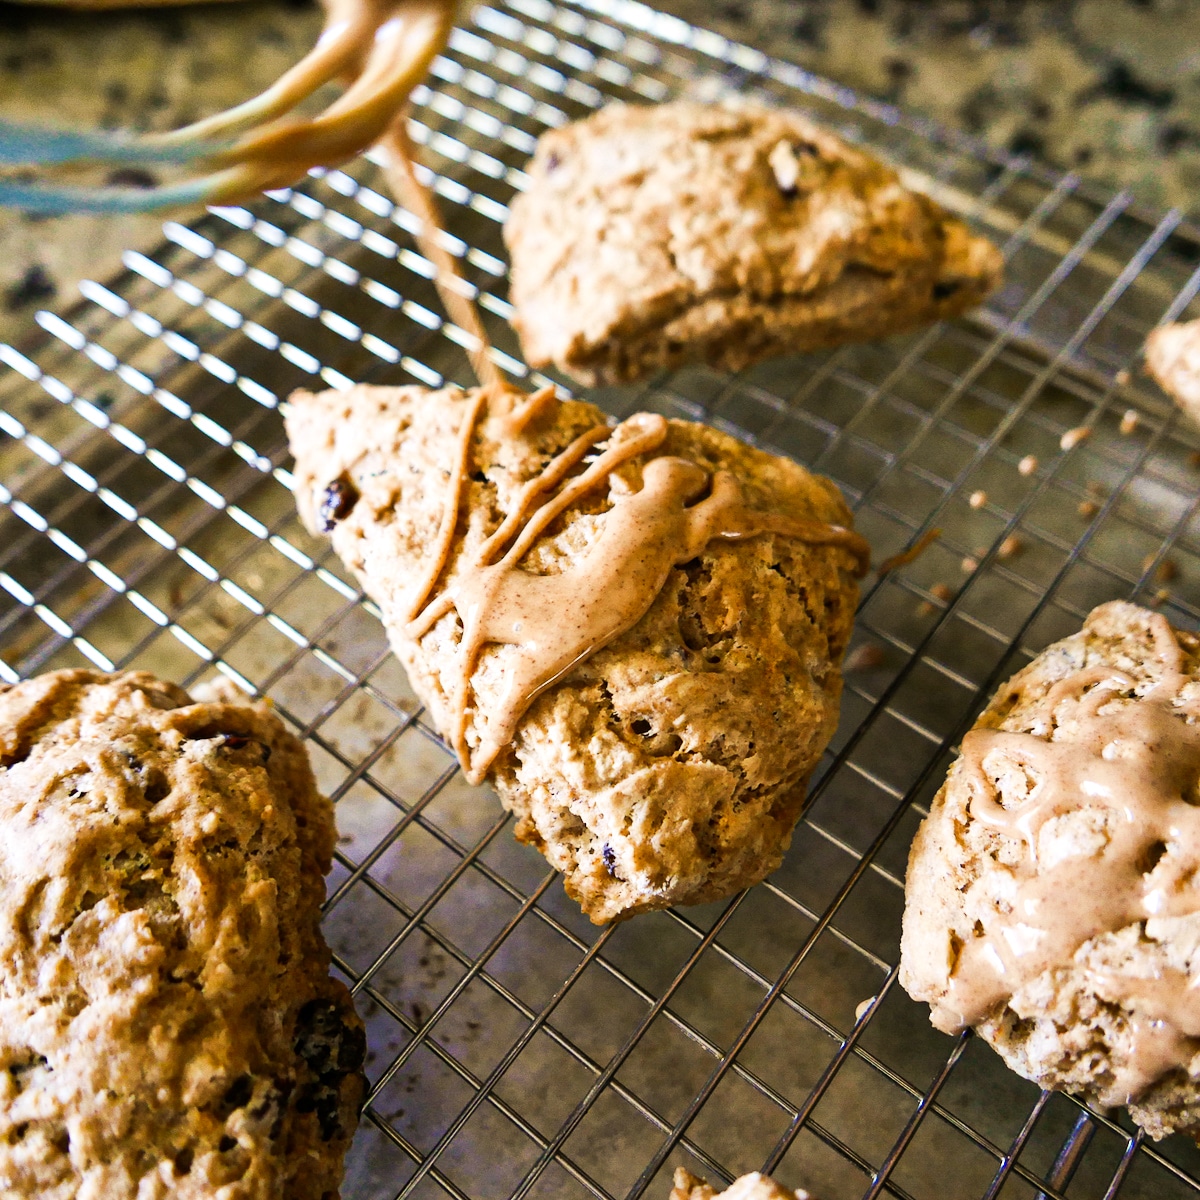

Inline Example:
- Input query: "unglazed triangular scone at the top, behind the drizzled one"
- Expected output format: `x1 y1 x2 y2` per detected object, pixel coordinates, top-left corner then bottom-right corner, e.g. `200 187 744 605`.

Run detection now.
504 101 1002 385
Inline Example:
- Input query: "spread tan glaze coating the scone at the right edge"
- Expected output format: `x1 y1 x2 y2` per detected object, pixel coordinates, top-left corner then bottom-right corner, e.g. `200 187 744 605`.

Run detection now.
932 614 1200 1104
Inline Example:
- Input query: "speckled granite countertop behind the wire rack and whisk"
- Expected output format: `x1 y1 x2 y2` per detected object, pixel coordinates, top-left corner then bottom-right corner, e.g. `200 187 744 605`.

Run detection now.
0 0 1200 340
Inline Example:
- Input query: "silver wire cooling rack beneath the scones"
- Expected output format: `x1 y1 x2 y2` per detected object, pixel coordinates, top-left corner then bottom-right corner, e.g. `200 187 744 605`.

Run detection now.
0 0 1200 1200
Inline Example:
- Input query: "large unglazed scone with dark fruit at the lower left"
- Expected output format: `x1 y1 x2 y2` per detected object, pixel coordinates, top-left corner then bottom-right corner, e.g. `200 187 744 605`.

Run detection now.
0 671 364 1200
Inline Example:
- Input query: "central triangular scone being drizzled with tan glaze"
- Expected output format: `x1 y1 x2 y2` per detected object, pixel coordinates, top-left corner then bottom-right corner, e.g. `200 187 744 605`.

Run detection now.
287 386 863 923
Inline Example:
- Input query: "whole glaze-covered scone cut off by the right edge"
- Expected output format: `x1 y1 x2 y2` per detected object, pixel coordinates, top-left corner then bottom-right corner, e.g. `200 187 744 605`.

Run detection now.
900 601 1200 1138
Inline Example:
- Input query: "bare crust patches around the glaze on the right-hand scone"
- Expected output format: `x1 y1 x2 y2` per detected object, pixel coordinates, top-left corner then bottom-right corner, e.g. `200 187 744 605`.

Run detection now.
900 601 1200 1138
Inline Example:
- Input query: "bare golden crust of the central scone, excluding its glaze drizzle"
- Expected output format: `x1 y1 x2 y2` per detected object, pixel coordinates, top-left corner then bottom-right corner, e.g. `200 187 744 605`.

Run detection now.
287 386 858 923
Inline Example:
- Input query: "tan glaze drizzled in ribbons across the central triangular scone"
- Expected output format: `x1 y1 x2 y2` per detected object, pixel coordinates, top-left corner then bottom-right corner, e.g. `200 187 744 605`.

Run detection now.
407 381 870 784
